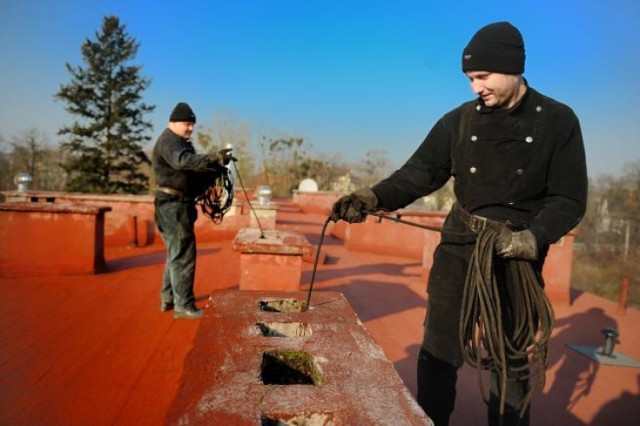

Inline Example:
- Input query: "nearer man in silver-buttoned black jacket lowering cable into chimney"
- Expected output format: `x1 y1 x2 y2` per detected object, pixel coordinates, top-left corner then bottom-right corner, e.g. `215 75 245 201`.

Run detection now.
332 22 587 426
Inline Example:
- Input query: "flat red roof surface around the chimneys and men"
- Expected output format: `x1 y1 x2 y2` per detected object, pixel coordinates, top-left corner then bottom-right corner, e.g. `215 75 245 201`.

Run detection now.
0 203 640 426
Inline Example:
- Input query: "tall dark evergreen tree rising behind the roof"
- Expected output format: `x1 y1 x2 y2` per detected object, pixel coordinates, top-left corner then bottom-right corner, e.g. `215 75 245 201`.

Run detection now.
55 16 155 194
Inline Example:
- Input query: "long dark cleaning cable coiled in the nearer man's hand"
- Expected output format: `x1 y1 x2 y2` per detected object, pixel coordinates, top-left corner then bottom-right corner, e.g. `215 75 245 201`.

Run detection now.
303 208 554 418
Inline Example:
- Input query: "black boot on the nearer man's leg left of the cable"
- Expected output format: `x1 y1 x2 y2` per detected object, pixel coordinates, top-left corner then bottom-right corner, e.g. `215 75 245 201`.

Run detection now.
417 348 458 426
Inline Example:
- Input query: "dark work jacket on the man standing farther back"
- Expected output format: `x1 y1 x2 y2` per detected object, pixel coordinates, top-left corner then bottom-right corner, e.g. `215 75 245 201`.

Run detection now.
151 129 222 198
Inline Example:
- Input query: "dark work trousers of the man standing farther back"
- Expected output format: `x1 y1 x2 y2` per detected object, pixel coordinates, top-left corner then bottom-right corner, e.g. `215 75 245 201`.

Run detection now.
154 195 198 309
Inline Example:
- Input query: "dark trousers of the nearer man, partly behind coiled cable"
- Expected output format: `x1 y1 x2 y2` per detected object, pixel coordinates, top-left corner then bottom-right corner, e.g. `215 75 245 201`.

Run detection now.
417 243 529 426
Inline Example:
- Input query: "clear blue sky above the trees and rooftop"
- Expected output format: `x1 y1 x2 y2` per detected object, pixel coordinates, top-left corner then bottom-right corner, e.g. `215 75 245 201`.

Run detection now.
0 0 640 177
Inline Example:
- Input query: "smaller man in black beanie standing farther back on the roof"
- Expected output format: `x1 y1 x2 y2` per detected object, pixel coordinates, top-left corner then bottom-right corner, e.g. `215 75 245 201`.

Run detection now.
152 102 232 319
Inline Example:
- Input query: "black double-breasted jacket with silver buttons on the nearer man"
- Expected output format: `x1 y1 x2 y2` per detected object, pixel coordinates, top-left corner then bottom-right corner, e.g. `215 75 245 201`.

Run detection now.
373 88 587 246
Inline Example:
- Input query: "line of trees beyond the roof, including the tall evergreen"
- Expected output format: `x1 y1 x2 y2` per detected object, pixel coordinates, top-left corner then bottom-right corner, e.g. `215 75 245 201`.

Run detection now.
0 16 640 253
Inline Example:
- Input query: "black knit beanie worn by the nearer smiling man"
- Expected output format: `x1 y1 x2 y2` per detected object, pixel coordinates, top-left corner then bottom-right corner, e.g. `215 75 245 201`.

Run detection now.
462 22 525 74
